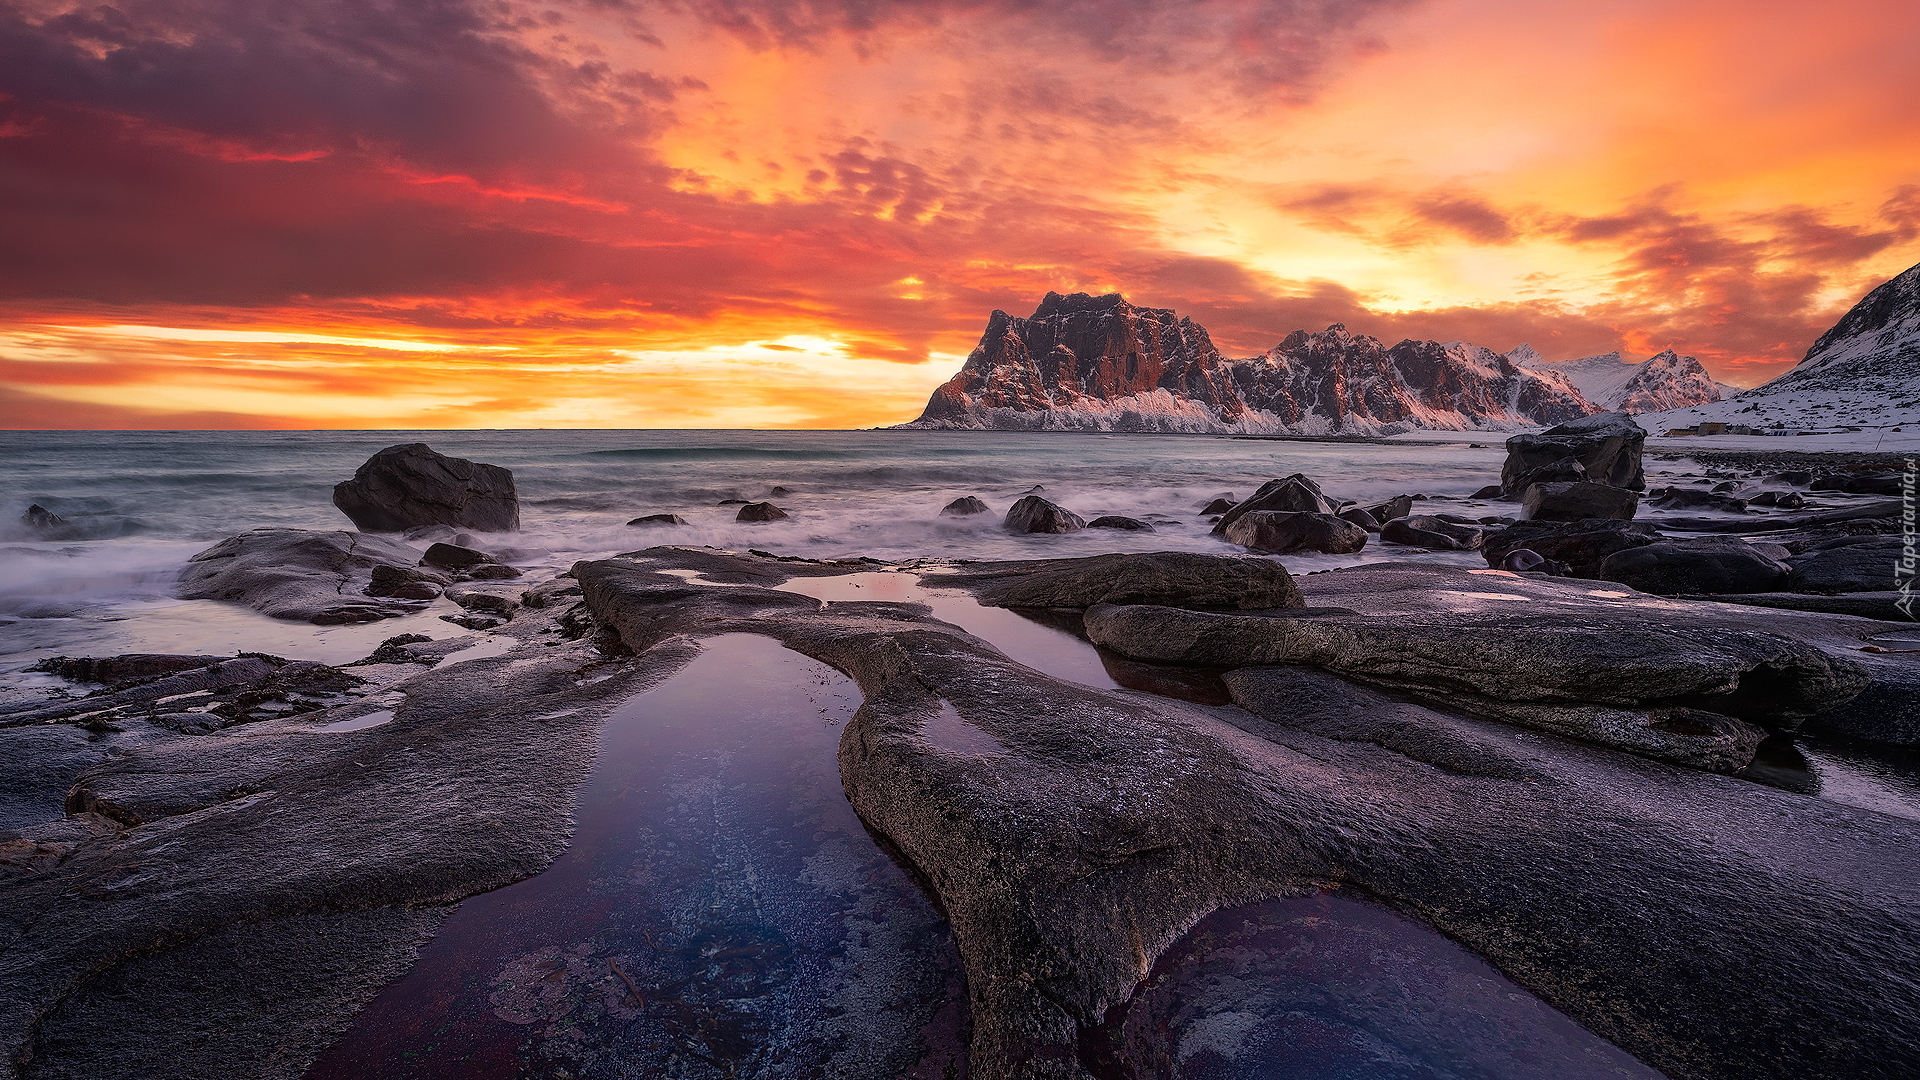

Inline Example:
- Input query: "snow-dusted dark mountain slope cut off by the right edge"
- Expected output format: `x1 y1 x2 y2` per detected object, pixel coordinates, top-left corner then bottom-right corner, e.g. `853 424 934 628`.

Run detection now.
1640 265 1920 430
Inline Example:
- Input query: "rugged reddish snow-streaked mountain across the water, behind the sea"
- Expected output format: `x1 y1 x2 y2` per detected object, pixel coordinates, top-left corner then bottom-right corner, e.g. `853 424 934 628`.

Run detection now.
904 292 1599 434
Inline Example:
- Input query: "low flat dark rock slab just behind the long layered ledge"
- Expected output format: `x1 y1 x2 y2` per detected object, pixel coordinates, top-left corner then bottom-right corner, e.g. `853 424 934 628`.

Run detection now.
927 552 1302 611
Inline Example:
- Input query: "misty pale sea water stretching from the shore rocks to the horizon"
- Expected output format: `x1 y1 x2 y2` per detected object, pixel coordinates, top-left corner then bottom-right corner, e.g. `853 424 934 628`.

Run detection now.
0 430 1511 664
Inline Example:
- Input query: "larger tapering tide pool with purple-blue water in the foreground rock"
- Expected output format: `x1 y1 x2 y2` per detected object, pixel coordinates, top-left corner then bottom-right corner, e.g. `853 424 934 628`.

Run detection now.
309 634 968 1080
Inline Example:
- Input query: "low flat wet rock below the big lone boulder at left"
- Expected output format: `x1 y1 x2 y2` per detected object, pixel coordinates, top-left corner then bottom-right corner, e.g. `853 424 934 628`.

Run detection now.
175 528 420 626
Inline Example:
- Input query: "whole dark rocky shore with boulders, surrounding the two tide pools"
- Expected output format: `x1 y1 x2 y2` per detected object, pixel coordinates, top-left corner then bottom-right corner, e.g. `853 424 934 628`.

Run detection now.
0 440 1920 1080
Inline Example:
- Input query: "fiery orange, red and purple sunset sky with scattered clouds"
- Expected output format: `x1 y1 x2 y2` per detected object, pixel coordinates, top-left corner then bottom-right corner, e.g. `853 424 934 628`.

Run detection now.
0 0 1920 429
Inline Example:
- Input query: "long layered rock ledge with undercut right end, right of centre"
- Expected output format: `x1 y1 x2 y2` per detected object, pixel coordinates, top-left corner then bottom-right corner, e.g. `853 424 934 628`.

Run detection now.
1085 605 1868 773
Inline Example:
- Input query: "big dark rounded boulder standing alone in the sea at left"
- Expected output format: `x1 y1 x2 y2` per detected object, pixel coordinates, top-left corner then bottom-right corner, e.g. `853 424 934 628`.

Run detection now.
334 442 520 532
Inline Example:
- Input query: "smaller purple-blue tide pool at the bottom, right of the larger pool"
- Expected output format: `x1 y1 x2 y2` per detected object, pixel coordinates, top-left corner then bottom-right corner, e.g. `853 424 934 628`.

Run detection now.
1083 894 1661 1080
